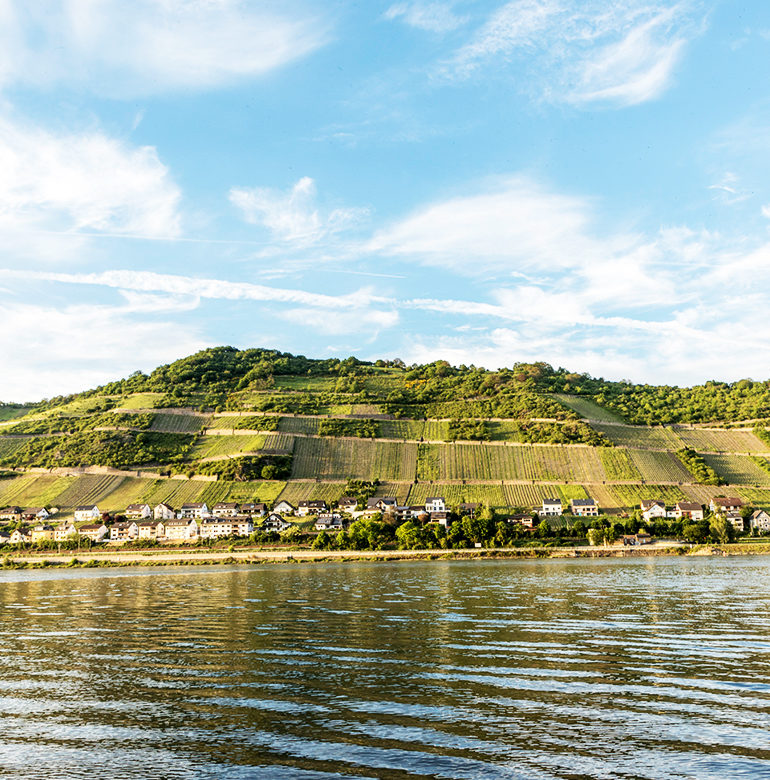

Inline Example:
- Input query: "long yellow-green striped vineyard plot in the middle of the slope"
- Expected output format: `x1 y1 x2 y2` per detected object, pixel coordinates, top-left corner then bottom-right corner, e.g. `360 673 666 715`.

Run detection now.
418 444 605 482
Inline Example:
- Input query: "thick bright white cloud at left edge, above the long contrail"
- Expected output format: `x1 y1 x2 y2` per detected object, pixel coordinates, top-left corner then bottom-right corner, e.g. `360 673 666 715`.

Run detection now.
0 113 181 244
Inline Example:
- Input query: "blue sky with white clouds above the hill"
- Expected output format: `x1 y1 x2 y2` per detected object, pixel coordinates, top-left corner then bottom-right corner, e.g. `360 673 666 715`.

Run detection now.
0 0 770 401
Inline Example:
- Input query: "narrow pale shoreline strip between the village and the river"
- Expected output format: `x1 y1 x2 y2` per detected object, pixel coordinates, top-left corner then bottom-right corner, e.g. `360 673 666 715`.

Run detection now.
6 542 770 569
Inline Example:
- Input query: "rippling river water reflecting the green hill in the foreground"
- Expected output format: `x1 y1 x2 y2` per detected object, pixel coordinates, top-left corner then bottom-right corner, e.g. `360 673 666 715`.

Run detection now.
0 558 770 780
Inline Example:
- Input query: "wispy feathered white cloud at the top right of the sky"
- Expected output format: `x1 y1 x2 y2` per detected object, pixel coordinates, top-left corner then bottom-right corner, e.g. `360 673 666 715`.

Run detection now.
442 0 698 105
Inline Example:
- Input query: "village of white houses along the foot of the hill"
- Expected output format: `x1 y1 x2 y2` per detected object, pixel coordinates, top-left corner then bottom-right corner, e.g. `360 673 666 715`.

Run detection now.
0 496 770 545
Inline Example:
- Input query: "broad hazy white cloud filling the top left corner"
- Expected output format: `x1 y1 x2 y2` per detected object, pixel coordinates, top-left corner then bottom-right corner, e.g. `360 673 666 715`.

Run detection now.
0 0 328 97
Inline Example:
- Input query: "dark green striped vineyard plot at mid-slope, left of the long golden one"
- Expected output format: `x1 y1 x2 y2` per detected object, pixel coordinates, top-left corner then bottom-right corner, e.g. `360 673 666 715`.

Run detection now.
292 438 417 482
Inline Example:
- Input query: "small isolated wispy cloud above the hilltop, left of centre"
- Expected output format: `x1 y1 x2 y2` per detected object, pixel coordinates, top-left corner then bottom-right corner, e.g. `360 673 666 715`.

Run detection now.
230 176 369 246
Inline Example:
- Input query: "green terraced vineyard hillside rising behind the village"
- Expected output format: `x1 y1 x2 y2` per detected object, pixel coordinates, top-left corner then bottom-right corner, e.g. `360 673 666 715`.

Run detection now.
0 347 770 511
